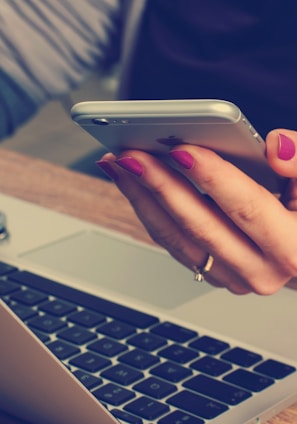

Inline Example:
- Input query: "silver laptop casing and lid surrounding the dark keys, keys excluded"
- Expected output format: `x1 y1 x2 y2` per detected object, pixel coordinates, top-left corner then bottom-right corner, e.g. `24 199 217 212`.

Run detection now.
0 195 297 424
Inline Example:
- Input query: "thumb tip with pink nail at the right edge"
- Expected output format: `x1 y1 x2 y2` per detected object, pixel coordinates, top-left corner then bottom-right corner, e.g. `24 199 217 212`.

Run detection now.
266 129 297 178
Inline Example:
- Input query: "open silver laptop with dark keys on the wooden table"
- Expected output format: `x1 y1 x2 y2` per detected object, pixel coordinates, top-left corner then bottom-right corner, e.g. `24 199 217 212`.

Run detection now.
0 194 297 424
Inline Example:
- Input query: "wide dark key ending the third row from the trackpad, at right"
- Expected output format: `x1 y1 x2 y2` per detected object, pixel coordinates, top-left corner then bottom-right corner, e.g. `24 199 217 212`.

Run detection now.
183 374 251 405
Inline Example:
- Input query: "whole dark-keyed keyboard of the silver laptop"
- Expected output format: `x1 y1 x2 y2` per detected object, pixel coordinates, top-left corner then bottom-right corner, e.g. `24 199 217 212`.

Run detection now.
0 262 296 424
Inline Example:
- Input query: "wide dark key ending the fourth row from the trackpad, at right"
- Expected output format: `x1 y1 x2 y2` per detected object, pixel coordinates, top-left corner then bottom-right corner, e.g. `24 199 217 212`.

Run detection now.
167 390 228 420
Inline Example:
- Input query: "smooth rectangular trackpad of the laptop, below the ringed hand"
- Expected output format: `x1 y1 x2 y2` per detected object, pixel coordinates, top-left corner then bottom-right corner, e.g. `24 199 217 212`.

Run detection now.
22 231 212 309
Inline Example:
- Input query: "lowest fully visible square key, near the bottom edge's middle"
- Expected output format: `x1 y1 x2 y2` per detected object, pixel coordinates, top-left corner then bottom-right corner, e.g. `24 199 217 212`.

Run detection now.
124 396 169 420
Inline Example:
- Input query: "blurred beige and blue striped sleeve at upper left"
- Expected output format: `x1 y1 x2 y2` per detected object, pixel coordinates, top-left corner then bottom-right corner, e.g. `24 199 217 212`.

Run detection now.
0 0 120 136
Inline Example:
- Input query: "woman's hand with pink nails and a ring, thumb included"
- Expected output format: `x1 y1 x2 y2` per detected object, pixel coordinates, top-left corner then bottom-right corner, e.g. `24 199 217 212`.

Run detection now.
98 130 297 295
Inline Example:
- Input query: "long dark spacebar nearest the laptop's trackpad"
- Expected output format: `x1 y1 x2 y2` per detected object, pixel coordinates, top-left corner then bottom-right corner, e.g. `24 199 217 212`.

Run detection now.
9 271 159 328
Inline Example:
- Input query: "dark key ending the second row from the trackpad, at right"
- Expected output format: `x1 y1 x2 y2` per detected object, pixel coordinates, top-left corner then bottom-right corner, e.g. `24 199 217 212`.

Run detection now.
223 369 274 392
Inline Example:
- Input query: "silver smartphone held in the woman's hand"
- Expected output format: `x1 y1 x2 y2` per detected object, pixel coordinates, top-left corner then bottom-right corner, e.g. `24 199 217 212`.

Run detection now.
71 99 284 193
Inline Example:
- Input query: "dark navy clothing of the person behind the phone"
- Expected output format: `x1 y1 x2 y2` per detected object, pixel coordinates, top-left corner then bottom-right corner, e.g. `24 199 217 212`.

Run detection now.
130 0 297 136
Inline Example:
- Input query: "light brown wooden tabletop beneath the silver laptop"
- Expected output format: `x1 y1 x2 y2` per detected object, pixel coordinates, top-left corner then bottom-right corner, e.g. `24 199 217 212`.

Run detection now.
0 148 297 424
